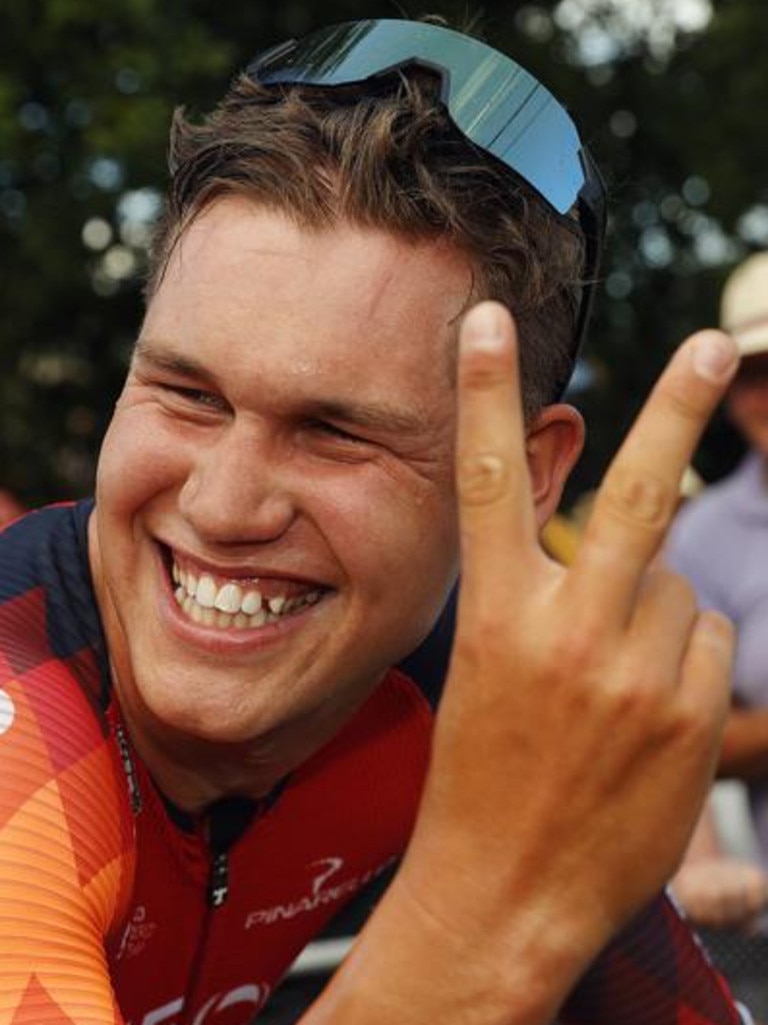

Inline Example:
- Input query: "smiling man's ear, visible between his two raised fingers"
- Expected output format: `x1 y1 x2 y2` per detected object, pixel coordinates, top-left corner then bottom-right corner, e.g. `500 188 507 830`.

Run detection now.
525 403 584 528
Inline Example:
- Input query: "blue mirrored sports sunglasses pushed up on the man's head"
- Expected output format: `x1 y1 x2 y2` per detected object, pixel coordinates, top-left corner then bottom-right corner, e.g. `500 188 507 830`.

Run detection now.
247 18 605 362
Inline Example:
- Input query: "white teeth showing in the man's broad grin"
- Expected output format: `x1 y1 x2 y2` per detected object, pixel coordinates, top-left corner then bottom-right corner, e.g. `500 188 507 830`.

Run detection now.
172 562 320 629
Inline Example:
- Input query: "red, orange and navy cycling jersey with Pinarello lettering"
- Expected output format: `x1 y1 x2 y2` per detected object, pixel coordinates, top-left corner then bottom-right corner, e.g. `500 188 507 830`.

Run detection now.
0 503 739 1025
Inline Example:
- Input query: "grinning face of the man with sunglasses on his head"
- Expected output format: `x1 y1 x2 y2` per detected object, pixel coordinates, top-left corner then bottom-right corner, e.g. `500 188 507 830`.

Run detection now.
91 197 472 758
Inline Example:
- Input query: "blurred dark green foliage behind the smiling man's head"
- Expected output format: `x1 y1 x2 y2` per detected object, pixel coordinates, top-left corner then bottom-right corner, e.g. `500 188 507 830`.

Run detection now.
0 0 768 503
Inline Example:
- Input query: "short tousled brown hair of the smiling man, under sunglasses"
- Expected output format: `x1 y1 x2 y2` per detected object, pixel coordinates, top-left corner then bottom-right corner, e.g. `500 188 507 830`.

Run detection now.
147 72 583 416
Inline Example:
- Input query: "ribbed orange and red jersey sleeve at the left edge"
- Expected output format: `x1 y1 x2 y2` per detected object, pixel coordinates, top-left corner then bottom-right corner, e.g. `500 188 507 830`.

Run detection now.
0 662 132 1025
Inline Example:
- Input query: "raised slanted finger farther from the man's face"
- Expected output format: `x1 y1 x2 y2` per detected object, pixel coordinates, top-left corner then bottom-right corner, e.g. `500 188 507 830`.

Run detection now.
571 330 738 617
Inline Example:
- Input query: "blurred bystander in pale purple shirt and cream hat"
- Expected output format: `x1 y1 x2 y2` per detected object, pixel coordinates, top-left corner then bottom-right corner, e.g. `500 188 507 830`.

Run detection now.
666 252 768 925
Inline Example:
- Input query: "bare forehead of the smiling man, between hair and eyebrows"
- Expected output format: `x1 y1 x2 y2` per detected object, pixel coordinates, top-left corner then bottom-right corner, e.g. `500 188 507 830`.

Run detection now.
145 197 475 403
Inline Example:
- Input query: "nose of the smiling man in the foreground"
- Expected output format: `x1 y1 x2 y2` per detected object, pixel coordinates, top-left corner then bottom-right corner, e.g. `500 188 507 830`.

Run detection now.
179 424 297 543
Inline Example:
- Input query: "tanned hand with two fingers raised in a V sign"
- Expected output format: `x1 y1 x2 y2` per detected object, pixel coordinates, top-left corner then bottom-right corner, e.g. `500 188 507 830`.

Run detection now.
401 303 737 1016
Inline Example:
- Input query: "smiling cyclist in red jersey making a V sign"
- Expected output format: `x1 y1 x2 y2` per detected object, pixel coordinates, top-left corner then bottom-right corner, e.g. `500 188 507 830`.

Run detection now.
0 21 749 1025
